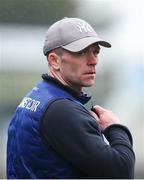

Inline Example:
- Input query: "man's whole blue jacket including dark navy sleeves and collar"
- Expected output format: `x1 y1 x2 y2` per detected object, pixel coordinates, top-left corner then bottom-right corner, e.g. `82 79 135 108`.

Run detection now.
7 74 135 179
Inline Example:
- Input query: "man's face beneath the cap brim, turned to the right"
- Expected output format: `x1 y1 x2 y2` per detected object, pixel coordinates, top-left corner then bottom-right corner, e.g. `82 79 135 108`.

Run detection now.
59 44 100 91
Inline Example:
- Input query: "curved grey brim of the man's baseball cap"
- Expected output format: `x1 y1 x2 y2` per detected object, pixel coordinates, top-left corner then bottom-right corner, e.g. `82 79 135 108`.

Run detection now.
62 37 111 52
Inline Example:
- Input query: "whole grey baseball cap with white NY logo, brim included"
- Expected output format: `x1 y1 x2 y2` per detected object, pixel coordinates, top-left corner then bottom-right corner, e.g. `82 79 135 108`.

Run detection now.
43 18 111 55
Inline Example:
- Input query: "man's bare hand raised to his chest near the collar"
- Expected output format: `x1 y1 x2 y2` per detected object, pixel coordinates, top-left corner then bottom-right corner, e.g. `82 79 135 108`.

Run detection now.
90 106 120 130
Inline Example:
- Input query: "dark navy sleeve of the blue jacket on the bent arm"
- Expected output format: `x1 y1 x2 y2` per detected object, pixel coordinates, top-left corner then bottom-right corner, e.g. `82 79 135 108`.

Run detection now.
41 100 135 179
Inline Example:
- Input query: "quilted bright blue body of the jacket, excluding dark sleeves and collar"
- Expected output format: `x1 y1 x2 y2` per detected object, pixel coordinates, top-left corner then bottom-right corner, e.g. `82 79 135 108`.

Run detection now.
7 81 84 179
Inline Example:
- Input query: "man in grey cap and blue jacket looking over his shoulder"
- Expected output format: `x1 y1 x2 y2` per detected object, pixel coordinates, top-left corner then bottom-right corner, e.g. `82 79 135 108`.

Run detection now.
7 18 135 179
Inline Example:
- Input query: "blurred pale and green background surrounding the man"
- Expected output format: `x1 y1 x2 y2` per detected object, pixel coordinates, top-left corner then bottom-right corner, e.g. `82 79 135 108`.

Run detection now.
0 0 144 178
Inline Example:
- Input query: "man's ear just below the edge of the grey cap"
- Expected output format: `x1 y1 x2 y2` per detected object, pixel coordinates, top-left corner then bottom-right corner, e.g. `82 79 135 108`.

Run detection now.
48 52 60 70
